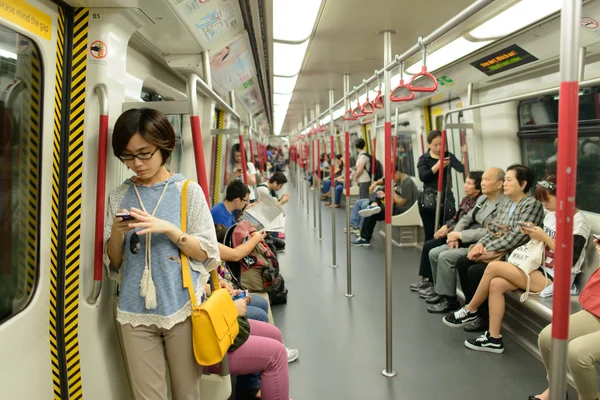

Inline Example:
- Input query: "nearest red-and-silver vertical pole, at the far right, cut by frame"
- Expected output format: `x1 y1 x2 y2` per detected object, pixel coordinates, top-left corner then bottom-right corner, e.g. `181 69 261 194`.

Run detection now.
550 0 582 400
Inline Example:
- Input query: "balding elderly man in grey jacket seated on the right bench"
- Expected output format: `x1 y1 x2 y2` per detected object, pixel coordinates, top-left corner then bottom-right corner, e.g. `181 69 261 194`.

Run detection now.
426 168 504 313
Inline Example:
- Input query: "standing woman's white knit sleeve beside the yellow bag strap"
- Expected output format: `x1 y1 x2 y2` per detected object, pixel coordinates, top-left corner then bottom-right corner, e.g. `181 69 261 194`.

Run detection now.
187 182 221 272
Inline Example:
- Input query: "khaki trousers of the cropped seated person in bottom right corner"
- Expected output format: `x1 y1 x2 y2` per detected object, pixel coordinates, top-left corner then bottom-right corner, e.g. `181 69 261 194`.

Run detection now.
538 310 600 400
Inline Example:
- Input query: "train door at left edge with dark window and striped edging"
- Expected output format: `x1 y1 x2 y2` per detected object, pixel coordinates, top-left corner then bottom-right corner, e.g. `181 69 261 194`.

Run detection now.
0 0 85 399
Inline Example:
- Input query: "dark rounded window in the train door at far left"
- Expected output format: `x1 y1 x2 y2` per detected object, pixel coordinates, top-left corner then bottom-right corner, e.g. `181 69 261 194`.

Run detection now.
0 26 42 323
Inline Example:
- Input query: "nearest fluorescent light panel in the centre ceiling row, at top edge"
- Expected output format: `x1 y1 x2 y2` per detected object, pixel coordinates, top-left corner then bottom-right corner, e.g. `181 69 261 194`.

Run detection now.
273 0 321 41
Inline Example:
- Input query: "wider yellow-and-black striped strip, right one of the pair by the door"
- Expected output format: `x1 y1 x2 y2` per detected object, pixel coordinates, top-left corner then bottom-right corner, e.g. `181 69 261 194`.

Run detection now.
64 8 89 400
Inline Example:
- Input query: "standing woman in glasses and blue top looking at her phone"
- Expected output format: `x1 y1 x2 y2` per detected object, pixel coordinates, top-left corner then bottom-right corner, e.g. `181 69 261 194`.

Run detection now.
104 108 219 400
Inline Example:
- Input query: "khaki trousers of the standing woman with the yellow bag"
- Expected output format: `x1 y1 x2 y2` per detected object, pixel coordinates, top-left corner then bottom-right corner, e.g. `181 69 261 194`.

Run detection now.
121 318 202 400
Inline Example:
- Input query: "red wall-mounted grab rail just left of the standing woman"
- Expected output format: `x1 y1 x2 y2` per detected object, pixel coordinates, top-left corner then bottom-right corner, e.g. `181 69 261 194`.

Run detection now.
87 84 108 305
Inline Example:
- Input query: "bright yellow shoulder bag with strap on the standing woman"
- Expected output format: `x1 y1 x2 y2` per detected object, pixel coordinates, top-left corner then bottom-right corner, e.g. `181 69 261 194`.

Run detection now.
181 181 239 366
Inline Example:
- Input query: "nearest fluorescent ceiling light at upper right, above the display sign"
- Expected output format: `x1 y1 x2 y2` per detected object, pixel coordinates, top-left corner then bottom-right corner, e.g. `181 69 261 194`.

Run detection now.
469 0 562 39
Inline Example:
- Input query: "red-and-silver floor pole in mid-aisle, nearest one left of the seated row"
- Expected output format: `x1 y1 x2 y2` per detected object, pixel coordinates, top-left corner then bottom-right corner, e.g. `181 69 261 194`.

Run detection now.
376 31 396 377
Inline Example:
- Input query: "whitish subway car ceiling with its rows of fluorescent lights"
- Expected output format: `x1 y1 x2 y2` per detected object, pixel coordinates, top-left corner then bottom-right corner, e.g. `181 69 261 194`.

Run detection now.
59 0 600 136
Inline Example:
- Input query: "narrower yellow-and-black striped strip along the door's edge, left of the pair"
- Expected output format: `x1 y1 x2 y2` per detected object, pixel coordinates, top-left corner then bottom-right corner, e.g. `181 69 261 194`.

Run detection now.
50 7 65 400
